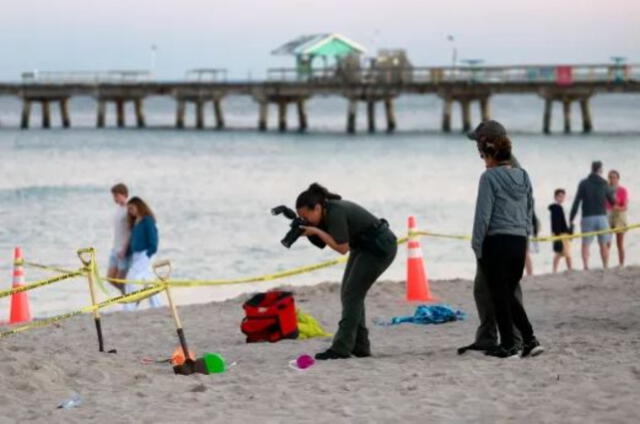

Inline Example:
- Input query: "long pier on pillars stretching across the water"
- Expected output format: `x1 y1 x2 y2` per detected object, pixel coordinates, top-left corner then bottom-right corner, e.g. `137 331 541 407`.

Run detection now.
0 64 640 133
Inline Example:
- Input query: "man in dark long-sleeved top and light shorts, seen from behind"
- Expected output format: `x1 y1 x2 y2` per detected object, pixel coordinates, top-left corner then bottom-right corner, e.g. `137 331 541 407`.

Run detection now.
569 161 616 269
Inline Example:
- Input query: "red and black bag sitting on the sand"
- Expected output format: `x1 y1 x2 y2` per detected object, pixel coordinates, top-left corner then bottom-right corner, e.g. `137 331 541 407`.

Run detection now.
240 290 298 343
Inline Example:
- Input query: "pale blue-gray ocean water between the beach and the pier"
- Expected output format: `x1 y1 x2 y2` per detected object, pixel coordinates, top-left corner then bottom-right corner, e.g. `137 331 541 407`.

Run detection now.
0 95 640 320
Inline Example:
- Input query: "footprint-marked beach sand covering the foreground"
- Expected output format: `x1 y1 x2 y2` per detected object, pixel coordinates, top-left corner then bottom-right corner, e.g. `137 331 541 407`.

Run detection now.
0 267 640 423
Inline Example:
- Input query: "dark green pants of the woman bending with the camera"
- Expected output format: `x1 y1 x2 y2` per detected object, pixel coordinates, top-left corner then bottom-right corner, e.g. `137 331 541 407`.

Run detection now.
331 244 398 355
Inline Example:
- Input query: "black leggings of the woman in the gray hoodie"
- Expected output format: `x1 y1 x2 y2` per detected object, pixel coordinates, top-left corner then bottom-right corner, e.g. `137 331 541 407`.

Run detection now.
480 234 533 349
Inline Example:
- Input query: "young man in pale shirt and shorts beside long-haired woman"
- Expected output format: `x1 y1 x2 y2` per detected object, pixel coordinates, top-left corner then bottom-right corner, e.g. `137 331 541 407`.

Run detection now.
107 183 131 294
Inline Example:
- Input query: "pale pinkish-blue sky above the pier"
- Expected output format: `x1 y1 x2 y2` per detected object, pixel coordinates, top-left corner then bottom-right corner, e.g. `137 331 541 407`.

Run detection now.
0 0 640 81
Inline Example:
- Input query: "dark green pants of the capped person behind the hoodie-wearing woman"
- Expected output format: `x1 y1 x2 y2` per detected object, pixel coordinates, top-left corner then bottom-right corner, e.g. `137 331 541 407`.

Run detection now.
473 258 522 347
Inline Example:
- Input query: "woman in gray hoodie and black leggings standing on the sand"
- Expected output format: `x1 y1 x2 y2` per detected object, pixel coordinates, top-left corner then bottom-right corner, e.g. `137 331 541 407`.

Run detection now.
471 136 543 358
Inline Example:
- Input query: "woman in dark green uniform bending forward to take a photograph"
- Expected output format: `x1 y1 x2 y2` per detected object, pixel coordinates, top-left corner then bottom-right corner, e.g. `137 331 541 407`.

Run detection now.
296 183 398 360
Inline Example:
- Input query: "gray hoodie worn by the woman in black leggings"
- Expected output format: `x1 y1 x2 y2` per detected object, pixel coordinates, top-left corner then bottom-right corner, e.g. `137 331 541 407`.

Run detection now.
471 166 533 259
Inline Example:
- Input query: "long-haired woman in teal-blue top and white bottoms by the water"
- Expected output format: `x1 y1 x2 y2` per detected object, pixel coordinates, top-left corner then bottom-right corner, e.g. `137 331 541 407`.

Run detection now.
124 197 160 310
